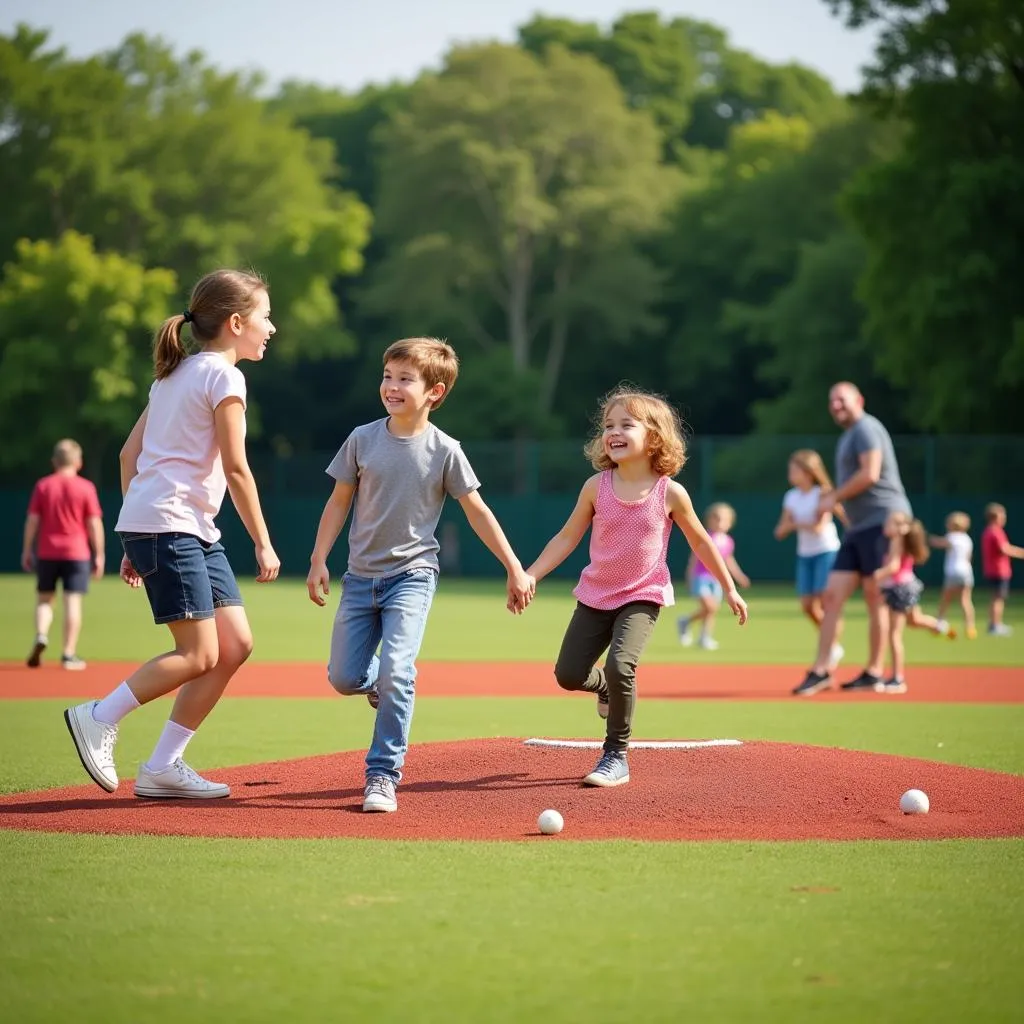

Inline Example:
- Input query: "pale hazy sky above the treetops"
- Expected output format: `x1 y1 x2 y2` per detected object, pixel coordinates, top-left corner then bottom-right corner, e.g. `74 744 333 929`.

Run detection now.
0 0 873 91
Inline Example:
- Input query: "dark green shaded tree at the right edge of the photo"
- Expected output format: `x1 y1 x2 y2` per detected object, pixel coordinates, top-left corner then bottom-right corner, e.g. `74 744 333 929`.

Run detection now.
830 0 1024 431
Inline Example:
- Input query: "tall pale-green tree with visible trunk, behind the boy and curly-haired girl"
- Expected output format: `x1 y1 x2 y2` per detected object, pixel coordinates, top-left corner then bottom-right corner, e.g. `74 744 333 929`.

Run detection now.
370 45 677 431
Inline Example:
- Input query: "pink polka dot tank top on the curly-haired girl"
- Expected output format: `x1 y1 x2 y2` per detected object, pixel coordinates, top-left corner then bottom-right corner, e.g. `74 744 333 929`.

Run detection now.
572 470 675 611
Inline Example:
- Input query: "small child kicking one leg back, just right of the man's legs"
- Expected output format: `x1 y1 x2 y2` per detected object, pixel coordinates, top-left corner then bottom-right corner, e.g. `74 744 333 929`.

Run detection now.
874 512 956 693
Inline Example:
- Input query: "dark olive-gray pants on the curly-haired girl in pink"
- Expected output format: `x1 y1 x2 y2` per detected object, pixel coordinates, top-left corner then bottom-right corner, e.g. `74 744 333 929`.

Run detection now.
555 601 662 751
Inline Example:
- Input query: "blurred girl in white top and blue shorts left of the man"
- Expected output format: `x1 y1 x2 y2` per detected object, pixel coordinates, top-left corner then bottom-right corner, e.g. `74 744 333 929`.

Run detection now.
775 449 843 665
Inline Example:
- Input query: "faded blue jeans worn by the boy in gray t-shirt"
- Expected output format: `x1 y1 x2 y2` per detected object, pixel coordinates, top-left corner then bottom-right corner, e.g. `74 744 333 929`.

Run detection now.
327 567 437 782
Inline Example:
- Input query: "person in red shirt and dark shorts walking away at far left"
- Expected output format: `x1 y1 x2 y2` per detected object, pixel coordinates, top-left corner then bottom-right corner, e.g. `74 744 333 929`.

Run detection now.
22 439 105 669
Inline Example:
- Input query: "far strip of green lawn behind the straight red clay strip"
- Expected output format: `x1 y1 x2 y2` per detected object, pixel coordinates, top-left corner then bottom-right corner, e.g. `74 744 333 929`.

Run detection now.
0 575 1024 667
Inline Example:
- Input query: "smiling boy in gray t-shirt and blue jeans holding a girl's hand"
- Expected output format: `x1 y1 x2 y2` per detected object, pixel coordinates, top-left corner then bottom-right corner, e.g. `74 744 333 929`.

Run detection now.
306 338 535 811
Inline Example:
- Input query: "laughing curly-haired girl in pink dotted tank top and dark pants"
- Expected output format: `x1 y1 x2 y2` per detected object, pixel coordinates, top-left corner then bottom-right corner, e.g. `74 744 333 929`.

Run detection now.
527 388 746 786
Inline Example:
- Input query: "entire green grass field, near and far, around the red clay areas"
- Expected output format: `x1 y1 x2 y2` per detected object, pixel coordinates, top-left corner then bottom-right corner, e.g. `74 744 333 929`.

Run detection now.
0 578 1024 1024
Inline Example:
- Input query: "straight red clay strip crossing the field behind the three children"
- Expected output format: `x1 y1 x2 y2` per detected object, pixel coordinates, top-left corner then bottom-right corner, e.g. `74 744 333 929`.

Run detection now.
0 662 1024 703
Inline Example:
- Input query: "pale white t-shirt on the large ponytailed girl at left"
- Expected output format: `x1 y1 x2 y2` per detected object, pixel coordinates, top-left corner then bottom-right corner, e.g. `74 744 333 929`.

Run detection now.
115 352 246 544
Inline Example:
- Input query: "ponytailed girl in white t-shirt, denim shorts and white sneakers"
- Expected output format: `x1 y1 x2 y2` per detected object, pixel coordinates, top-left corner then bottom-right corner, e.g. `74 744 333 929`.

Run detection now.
65 270 281 800
